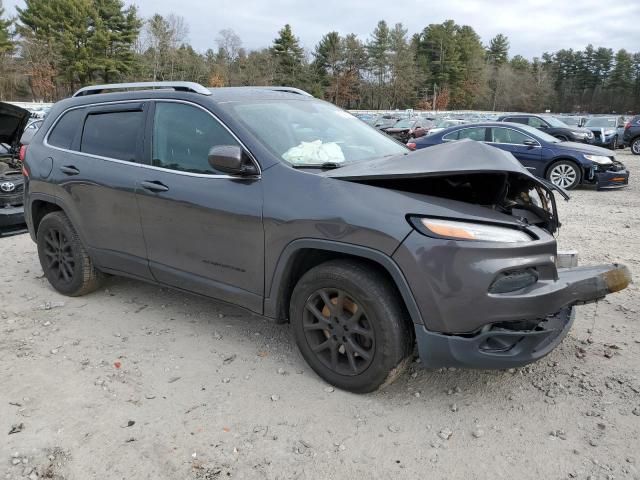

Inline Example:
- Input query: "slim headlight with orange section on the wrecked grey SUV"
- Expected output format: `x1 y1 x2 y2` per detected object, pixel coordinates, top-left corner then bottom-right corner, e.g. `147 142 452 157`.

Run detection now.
420 218 532 243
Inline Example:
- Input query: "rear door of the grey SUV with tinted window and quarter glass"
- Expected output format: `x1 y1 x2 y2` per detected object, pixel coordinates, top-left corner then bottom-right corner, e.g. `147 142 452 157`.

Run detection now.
46 101 151 278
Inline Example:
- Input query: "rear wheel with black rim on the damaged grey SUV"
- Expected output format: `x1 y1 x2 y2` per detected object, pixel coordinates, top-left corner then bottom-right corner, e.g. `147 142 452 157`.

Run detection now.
37 212 102 297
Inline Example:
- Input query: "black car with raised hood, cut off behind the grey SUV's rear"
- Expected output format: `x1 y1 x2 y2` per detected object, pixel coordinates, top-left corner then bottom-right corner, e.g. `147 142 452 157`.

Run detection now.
0 102 30 233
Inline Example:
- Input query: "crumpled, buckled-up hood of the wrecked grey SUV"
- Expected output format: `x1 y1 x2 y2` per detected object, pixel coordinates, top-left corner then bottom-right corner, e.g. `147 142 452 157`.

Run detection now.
321 140 539 181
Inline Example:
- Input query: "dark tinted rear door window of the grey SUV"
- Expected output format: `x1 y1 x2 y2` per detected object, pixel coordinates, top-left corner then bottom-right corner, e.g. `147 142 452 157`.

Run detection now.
80 111 144 162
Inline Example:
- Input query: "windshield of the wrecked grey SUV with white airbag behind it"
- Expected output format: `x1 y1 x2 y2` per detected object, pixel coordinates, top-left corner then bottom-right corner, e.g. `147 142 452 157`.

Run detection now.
230 100 407 166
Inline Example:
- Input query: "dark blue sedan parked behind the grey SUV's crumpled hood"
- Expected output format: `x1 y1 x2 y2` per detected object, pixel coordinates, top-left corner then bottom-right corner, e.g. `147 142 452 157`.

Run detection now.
407 122 629 190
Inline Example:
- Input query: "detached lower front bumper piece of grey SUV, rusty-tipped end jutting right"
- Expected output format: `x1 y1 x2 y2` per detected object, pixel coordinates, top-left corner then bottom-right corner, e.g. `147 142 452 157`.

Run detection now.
415 264 631 369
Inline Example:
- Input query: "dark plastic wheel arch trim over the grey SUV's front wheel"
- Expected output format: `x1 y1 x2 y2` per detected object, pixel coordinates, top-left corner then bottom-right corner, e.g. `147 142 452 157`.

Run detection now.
264 239 423 324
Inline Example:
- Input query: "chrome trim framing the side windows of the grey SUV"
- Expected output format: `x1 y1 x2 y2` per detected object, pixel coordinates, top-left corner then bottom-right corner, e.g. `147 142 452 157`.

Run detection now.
43 98 262 180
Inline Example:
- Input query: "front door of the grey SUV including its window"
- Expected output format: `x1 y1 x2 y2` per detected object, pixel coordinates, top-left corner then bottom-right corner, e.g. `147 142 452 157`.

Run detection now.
136 101 264 313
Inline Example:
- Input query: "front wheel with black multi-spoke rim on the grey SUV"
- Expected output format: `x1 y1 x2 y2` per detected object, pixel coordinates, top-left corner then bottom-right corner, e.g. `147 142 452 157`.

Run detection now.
290 260 414 393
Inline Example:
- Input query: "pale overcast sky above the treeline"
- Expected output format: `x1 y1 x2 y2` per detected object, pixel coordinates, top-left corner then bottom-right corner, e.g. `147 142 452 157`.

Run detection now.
4 0 640 58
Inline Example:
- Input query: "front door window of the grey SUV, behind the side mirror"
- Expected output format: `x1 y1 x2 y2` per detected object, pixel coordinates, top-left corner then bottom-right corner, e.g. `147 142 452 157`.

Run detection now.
152 102 238 174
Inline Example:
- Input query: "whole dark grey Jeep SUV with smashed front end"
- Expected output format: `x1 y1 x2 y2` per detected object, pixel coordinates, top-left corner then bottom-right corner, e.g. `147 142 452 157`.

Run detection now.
24 82 630 392
